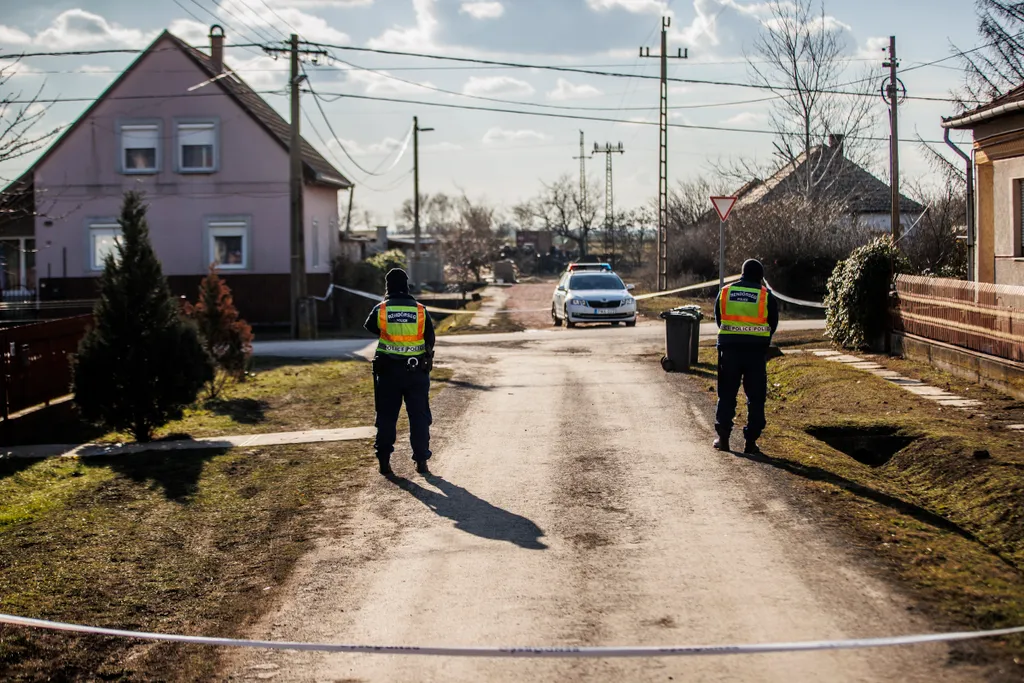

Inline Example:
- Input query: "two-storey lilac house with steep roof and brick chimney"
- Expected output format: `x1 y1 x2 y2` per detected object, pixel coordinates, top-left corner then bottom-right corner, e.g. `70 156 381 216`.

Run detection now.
0 27 351 324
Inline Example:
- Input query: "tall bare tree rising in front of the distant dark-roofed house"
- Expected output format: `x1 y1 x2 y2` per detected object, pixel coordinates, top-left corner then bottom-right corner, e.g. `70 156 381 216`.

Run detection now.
746 0 874 189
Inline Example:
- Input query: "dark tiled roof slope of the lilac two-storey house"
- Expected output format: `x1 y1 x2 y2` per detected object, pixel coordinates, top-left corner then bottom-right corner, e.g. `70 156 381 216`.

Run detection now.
172 33 352 188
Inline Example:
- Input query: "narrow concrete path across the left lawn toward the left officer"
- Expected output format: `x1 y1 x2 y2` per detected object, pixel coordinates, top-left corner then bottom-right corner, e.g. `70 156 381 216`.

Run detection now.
0 427 377 459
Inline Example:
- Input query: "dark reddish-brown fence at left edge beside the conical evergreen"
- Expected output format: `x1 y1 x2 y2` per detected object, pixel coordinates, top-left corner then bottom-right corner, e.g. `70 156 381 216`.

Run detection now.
0 315 92 420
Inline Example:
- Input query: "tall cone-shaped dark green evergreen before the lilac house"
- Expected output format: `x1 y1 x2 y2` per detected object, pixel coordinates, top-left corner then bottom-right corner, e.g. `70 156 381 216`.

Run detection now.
74 191 213 441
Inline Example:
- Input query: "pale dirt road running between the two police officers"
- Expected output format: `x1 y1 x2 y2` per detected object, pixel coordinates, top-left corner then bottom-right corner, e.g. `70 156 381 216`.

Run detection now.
225 317 977 683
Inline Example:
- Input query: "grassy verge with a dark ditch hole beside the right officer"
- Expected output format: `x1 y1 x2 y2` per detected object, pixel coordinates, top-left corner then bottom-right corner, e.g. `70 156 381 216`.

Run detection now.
700 348 1024 675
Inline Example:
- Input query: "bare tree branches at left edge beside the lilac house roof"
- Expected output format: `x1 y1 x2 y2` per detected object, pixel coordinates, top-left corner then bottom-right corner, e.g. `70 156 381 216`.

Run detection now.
0 59 60 222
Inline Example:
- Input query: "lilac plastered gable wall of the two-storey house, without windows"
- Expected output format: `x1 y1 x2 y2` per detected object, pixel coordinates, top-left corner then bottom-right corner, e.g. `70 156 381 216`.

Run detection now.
35 33 289 278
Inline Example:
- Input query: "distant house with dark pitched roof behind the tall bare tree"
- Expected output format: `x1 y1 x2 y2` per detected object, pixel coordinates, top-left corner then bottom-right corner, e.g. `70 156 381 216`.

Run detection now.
733 135 925 231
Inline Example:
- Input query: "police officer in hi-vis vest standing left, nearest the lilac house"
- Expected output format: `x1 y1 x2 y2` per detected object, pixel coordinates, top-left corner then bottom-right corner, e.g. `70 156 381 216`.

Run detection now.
364 268 434 476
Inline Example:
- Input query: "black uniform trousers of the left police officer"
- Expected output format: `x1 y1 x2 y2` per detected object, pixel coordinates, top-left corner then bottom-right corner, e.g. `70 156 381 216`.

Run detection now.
374 358 433 462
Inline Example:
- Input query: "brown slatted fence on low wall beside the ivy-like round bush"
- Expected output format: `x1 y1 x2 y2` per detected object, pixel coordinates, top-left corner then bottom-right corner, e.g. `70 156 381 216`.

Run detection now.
894 275 1024 362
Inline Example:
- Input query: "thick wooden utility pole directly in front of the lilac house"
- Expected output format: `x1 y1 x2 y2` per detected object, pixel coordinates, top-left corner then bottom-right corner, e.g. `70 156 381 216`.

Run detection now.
263 33 327 339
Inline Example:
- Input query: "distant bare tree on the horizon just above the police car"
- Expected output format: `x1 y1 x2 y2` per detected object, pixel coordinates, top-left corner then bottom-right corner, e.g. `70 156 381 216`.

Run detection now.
513 175 601 256
